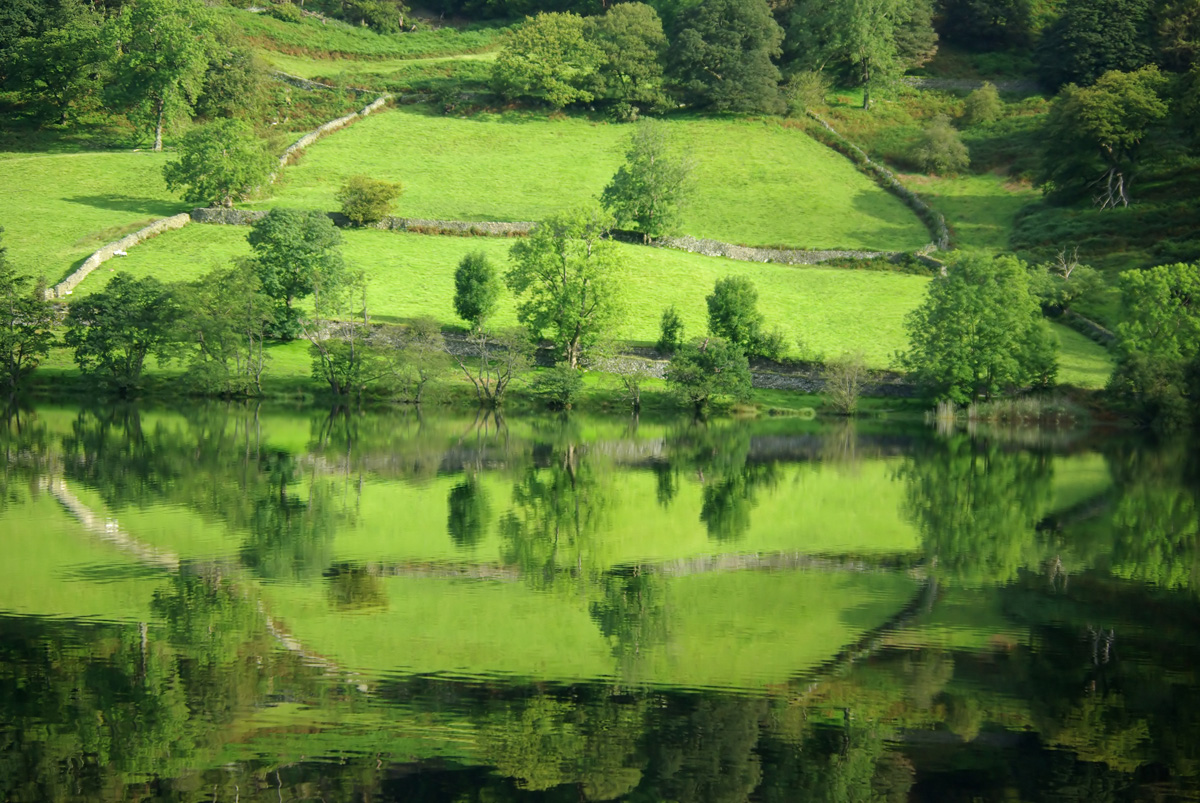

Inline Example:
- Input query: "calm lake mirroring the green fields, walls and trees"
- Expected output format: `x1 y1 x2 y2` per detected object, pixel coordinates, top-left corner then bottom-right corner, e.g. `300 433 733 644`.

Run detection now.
0 406 1200 803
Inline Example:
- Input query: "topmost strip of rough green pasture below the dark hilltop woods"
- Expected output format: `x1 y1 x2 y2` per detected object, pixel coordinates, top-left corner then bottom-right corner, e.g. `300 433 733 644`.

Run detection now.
221 6 504 59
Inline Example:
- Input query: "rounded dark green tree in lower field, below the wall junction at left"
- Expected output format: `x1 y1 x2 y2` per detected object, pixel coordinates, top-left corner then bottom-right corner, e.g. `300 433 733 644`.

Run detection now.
246 209 344 340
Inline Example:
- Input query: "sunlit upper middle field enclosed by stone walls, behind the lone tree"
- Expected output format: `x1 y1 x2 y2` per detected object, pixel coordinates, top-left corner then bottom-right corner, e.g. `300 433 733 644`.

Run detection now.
256 108 929 251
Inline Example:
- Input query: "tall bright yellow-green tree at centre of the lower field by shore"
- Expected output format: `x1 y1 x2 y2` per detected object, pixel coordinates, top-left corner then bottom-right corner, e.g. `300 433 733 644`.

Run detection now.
504 205 625 368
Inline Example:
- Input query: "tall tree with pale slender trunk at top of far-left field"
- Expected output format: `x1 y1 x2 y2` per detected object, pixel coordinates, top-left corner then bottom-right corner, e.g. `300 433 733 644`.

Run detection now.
114 0 215 150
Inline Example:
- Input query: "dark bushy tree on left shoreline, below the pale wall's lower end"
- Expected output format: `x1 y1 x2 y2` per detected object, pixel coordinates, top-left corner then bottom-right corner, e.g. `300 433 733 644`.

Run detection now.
64 271 180 394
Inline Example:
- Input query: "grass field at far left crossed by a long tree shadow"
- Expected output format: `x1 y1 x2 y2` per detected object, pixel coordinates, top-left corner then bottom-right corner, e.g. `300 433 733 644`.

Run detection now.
0 151 190 282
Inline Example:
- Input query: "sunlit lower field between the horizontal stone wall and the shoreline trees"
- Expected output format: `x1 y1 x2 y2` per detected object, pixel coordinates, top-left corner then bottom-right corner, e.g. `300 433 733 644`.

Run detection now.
76 224 928 367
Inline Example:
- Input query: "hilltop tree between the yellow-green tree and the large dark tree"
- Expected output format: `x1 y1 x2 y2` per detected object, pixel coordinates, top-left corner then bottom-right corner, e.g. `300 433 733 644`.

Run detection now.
588 2 667 110
